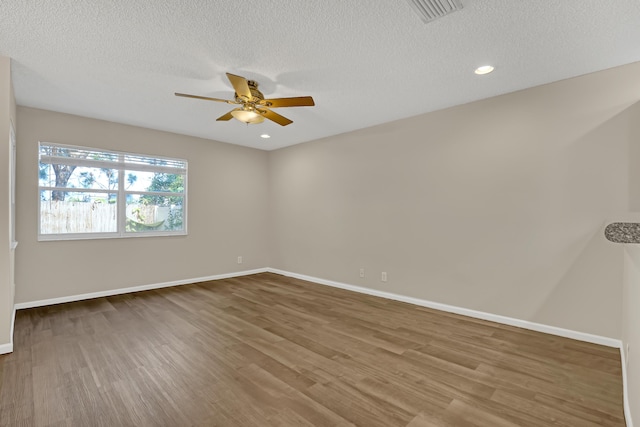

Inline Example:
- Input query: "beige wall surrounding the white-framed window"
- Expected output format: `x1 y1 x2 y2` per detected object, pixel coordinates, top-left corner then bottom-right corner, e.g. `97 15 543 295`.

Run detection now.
16 107 269 303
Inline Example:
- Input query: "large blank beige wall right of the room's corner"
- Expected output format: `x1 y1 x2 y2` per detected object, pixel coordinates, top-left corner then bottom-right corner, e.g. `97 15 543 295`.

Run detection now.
269 63 640 339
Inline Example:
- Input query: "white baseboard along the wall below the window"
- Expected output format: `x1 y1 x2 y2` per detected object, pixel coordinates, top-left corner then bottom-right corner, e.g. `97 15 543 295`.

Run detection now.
15 268 268 310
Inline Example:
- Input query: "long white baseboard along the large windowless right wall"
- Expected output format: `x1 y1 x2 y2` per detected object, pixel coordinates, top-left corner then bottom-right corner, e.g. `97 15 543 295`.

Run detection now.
267 268 622 348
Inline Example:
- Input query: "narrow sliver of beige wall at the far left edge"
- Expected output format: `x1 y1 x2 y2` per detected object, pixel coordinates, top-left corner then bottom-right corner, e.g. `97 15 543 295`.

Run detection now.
0 56 15 353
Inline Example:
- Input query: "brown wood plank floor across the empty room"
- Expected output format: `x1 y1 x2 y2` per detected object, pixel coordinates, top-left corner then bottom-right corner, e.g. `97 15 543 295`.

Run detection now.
0 273 624 427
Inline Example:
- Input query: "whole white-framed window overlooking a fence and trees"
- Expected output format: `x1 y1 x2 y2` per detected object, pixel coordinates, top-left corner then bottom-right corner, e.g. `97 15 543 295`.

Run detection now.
38 142 187 240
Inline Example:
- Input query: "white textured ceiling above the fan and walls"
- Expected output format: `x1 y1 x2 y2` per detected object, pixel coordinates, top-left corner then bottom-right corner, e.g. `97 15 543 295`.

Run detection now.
0 0 640 149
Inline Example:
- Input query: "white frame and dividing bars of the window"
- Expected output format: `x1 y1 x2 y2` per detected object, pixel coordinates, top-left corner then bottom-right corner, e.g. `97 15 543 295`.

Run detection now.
37 142 188 241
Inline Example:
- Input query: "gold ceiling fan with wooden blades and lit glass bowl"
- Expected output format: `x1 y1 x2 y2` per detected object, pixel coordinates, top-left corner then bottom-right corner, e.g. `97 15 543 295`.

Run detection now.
175 73 315 126
